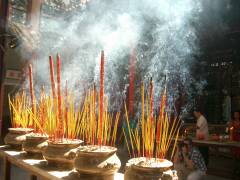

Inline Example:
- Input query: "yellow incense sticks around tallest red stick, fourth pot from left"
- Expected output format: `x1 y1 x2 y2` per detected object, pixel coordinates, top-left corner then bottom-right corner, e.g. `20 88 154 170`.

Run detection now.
76 87 120 146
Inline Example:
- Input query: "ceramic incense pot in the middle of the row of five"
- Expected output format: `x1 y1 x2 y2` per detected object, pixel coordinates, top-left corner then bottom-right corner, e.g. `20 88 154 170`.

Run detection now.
42 139 83 169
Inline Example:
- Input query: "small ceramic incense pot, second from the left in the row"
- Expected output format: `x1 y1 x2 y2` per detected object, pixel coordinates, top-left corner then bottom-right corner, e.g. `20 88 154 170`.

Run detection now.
22 133 48 158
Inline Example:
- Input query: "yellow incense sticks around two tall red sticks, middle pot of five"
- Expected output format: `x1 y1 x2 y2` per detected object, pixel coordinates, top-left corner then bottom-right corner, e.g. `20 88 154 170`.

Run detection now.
29 90 82 142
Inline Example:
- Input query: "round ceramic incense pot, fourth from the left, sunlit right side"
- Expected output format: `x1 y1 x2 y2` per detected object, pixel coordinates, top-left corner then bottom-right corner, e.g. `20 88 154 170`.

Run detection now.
74 145 121 180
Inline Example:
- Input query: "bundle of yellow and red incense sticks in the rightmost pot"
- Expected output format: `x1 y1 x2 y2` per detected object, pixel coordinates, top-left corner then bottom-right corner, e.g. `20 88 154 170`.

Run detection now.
123 80 180 158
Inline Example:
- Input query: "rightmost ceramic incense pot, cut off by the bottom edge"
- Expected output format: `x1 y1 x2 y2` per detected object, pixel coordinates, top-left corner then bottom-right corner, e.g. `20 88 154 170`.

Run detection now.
124 157 176 180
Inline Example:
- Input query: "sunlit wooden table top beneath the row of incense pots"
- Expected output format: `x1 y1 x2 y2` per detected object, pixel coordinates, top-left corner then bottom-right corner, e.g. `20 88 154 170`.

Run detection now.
0 145 124 180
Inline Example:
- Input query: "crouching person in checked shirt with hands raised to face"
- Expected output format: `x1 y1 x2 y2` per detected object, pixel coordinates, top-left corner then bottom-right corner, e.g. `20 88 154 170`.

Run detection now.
173 138 207 180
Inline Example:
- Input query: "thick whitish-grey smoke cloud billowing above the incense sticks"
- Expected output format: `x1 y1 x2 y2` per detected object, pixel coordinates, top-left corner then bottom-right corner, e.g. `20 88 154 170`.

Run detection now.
19 0 231 114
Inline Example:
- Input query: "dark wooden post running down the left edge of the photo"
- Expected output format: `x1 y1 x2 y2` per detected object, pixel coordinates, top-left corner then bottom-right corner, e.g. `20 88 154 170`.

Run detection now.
0 0 9 136
